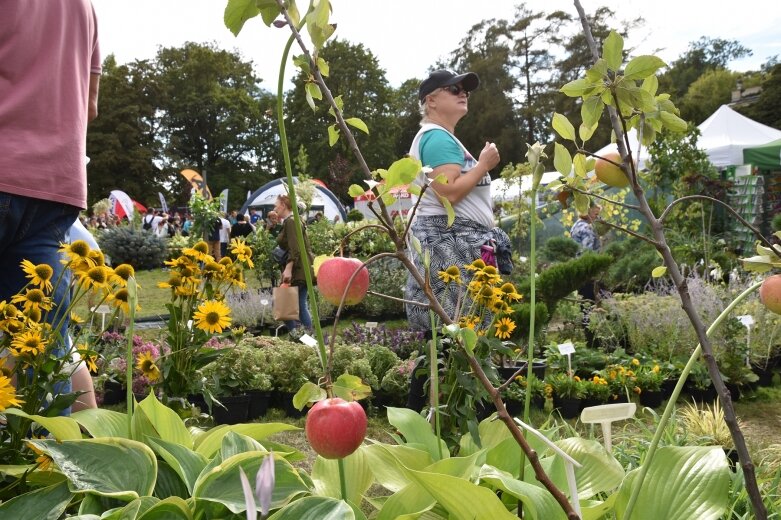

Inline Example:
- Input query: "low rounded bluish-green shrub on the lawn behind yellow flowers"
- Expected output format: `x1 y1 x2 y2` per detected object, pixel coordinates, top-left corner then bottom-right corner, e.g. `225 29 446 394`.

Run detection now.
98 226 167 271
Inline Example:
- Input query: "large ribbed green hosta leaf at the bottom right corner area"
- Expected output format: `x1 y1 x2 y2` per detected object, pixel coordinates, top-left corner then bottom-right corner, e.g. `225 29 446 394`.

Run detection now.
616 446 730 520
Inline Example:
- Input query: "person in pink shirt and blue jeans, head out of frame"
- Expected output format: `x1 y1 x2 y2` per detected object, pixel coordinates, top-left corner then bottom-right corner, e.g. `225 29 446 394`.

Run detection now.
0 0 101 413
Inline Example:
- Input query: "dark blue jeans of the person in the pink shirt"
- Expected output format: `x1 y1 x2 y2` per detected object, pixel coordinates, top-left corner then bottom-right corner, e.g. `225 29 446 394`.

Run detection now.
0 192 79 410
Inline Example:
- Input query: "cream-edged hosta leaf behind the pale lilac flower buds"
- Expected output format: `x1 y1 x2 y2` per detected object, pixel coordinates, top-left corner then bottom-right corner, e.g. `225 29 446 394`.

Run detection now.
193 451 310 513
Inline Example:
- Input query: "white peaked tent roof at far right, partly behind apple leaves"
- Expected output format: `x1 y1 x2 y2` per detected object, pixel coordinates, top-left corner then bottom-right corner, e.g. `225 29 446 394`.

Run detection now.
596 105 781 170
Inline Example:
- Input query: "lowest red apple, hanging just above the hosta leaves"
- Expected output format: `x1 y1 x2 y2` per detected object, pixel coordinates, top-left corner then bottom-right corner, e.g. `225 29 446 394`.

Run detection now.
306 397 366 459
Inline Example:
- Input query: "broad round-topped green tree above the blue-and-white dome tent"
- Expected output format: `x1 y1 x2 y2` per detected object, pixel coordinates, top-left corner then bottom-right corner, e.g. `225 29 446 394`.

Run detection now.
155 42 278 207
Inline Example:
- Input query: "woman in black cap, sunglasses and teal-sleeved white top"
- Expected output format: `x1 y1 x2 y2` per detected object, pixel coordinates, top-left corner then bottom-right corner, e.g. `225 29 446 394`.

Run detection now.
406 70 510 330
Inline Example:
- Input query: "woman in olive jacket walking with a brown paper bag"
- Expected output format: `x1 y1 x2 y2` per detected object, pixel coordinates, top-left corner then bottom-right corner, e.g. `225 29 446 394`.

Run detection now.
274 195 314 331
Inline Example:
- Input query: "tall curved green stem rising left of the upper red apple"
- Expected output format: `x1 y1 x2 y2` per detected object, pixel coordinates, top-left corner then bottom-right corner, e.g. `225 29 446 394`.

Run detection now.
277 30 328 378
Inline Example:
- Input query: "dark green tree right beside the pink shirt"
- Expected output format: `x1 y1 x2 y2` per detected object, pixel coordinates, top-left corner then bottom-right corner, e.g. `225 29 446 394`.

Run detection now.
87 55 166 206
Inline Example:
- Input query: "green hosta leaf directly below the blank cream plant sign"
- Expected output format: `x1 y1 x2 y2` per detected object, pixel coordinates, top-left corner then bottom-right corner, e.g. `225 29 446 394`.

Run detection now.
556 437 624 499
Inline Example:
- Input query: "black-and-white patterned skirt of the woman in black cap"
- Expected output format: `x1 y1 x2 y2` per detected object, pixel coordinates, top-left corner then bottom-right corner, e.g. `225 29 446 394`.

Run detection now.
405 216 492 330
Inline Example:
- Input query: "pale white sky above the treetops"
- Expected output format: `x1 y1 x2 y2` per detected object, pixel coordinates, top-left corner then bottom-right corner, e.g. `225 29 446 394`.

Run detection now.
92 0 781 90
